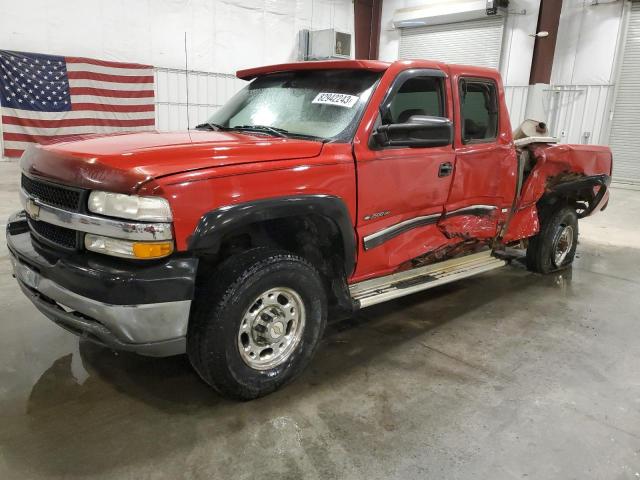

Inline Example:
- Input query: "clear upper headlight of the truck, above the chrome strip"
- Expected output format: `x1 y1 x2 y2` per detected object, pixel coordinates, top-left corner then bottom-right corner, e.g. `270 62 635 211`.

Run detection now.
89 190 171 222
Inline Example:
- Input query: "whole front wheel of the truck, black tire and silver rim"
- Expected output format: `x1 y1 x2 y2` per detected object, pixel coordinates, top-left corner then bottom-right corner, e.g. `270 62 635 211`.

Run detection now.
187 248 327 400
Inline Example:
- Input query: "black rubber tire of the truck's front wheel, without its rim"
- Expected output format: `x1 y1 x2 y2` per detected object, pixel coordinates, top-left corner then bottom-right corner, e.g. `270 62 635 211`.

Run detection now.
187 248 327 400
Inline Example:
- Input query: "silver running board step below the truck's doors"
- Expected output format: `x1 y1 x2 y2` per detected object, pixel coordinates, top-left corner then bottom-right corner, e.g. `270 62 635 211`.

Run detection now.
349 251 507 308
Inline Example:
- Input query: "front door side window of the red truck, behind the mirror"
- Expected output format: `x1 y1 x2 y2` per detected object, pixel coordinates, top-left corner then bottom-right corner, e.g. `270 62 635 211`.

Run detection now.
382 77 445 125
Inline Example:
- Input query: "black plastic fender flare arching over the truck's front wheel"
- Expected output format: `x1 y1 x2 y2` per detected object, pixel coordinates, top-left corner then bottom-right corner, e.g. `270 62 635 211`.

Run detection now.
188 195 356 276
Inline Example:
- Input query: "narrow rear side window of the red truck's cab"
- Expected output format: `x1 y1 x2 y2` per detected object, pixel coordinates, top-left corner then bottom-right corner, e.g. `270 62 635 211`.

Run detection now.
460 79 498 143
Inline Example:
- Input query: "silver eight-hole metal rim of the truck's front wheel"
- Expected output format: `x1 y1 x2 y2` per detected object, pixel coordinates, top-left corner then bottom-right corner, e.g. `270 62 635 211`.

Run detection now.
238 287 305 370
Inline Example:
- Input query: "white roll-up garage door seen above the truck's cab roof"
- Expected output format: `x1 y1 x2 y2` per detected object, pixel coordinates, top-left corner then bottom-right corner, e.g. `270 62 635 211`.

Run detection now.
400 16 504 69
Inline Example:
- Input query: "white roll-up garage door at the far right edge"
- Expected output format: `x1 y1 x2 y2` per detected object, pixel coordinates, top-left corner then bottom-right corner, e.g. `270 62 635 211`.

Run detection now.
609 2 640 184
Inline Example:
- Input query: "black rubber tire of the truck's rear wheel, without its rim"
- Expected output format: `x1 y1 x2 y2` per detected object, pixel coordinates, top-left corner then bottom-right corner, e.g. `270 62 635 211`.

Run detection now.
527 205 578 273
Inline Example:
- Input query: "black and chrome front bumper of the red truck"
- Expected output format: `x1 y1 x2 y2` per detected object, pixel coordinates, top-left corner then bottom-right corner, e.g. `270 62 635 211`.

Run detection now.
7 214 198 356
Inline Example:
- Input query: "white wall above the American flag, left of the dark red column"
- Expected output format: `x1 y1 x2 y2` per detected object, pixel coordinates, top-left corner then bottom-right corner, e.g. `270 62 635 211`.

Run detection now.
0 0 354 144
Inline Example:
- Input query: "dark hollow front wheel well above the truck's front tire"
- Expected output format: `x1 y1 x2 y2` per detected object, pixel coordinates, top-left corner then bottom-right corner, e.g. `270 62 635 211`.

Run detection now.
198 214 353 313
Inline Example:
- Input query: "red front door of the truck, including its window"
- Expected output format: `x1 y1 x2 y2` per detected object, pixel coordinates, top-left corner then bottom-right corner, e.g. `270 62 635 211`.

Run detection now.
353 69 455 281
